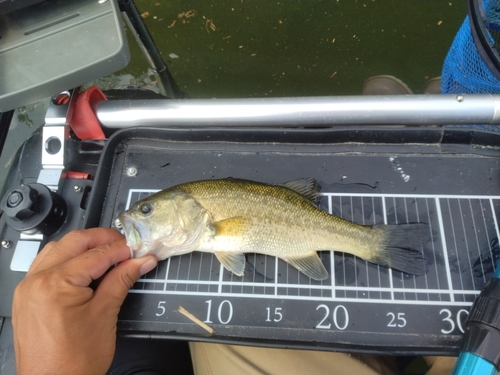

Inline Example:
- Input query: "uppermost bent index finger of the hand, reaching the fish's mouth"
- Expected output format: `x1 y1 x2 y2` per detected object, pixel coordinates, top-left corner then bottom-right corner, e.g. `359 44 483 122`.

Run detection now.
36 228 124 270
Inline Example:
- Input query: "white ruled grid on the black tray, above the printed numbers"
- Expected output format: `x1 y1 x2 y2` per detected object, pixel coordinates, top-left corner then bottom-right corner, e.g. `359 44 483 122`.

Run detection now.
126 189 500 306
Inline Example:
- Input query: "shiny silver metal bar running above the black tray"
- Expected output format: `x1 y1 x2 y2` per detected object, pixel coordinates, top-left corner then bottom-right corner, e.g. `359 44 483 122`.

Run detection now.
95 95 500 129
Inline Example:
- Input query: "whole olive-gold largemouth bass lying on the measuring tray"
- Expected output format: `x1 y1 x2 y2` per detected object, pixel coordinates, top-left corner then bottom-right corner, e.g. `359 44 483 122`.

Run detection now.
118 179 429 280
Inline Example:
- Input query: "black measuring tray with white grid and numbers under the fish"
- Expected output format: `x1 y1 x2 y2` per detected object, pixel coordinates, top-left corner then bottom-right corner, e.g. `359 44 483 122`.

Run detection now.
87 129 500 355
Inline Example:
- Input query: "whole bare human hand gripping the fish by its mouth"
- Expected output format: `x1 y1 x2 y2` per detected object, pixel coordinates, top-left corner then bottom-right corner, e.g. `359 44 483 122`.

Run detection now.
12 228 157 375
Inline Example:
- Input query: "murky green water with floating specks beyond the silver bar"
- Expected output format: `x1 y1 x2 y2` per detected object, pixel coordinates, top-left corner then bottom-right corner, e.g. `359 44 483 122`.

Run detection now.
123 0 467 98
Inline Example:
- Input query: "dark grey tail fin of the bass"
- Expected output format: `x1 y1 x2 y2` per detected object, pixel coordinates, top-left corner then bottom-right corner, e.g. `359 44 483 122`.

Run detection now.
370 223 430 275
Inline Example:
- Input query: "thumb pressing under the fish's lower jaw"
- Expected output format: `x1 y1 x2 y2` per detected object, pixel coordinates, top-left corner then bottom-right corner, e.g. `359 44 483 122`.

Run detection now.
92 255 158 314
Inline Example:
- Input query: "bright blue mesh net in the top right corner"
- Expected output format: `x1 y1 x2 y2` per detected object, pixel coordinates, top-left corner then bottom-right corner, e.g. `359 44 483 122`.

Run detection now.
441 0 500 132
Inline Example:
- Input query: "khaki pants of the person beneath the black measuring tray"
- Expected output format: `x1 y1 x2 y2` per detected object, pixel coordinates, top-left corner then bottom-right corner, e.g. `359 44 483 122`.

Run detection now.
189 342 456 375
